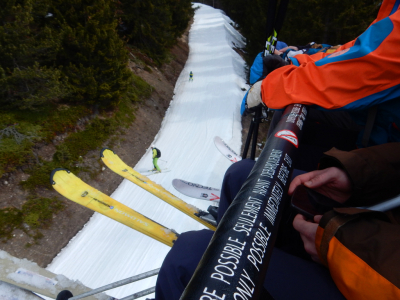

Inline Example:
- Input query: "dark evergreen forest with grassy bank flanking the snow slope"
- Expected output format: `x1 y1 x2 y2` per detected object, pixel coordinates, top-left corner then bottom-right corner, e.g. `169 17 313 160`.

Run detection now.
0 0 380 246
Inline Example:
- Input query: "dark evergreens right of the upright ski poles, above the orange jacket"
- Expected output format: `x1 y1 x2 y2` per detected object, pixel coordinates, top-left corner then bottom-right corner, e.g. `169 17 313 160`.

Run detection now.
281 0 380 45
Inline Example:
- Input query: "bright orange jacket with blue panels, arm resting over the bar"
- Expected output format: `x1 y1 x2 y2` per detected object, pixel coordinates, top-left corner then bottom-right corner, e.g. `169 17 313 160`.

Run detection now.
261 0 400 145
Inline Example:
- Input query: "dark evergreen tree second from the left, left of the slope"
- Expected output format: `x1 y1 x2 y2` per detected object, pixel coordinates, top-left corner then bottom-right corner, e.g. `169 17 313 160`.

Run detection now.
52 0 132 107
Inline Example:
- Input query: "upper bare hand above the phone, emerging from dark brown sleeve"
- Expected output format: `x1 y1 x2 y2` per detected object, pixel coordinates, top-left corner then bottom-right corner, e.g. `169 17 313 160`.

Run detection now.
288 167 353 203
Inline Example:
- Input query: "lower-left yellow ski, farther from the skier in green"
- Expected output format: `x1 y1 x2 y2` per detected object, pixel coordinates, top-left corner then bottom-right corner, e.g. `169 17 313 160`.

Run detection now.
50 168 178 247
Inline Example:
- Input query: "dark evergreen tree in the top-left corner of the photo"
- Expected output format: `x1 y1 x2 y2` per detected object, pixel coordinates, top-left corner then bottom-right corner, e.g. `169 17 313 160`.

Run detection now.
0 0 67 109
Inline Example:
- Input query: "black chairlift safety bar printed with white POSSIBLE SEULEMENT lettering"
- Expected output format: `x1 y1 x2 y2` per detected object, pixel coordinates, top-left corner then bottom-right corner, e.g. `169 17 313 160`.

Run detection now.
180 104 307 300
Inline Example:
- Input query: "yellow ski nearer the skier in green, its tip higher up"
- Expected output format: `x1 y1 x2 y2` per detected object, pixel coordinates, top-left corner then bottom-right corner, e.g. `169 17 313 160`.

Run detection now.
100 148 216 230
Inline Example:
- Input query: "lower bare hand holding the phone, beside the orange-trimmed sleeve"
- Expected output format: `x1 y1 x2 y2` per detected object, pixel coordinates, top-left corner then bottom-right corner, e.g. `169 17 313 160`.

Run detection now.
293 214 322 263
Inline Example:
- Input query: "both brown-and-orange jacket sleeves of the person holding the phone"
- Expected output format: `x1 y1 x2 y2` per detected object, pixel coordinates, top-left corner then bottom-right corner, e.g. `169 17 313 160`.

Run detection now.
316 143 400 300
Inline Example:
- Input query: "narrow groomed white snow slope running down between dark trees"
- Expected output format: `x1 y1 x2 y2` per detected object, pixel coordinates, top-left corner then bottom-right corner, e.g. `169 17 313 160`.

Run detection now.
43 3 247 298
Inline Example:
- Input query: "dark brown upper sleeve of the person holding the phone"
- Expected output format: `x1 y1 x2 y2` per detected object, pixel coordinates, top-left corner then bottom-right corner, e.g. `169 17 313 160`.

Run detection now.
319 143 400 206
